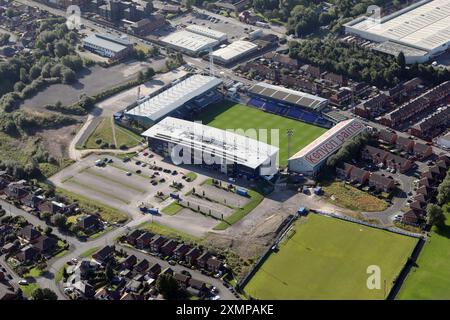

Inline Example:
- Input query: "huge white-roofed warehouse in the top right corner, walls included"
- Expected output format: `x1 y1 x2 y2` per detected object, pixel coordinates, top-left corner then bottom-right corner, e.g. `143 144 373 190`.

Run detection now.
345 0 450 63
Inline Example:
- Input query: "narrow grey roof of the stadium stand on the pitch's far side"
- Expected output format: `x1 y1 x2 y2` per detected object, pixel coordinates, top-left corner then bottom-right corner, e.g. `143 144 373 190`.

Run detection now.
249 82 328 110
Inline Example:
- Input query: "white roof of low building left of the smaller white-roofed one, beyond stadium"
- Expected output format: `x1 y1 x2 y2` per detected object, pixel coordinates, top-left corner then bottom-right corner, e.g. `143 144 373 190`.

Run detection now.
161 30 219 52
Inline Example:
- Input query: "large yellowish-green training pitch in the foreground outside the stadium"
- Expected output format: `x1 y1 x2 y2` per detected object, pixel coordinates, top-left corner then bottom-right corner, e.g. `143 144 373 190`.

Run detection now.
244 214 417 299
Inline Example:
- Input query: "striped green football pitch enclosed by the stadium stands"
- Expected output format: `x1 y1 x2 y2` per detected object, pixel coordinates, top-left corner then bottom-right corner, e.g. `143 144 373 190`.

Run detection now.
198 101 327 167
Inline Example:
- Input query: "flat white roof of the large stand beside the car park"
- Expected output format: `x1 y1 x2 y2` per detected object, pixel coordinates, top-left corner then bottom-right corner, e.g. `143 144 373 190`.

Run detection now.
142 117 278 169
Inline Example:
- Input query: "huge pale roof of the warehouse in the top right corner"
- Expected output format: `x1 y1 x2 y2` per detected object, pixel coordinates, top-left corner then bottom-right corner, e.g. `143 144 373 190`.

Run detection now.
348 0 450 51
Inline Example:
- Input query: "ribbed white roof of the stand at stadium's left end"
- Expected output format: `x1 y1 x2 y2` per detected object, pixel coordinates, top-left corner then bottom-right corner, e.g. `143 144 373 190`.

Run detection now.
126 75 222 121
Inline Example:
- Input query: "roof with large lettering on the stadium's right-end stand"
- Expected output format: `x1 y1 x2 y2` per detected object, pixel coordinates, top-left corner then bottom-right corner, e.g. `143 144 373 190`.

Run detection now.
289 119 366 167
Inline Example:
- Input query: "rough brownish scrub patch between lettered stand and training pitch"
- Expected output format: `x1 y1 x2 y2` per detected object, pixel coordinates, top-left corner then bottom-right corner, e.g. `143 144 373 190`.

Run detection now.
322 181 388 212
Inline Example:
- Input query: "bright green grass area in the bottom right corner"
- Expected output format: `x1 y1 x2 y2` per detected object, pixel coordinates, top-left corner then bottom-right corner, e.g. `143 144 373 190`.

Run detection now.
397 204 450 300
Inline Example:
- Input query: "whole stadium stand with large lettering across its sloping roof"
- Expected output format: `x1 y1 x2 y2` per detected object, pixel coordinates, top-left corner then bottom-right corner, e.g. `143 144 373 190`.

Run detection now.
288 119 366 176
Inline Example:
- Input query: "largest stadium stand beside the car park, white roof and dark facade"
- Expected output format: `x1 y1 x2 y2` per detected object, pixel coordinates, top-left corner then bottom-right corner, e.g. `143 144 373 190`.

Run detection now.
142 117 278 178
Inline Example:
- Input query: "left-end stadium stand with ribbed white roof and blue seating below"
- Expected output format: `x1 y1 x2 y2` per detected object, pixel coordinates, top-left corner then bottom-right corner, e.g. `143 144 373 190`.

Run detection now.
125 75 222 127
